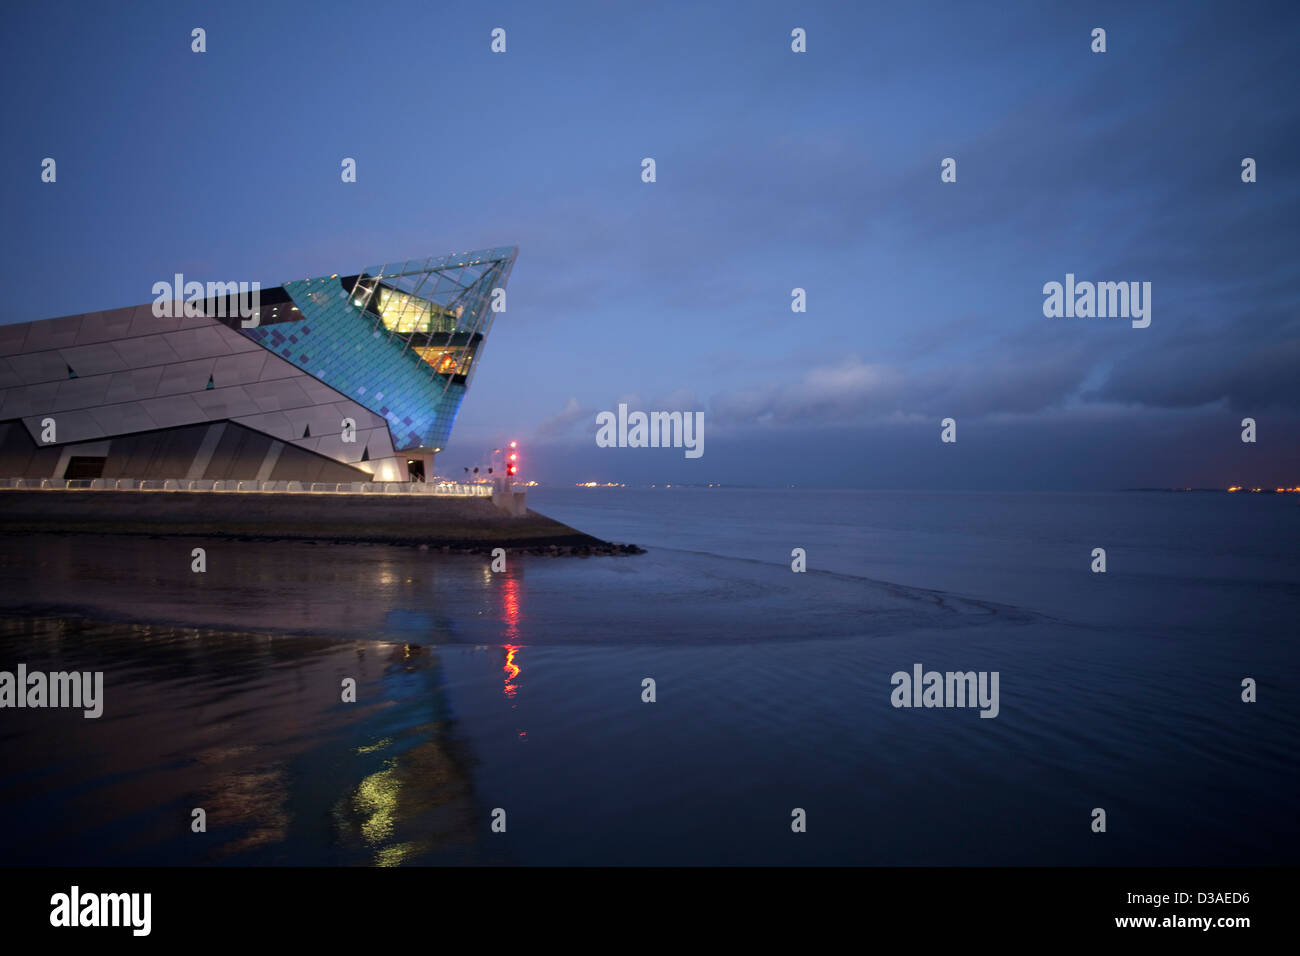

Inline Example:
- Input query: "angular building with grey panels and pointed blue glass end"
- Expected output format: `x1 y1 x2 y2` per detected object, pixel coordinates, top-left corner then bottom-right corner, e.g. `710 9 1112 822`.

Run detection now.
0 247 516 481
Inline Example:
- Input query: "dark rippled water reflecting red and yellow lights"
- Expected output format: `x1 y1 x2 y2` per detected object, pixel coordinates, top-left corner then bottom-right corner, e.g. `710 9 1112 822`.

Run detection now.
0 489 1300 865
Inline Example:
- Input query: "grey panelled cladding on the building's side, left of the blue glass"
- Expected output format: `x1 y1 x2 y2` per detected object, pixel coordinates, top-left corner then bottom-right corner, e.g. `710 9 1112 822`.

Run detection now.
0 306 404 481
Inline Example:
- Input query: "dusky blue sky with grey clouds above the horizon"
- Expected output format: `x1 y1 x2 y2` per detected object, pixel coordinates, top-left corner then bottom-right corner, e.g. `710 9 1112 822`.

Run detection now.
0 1 1300 490
